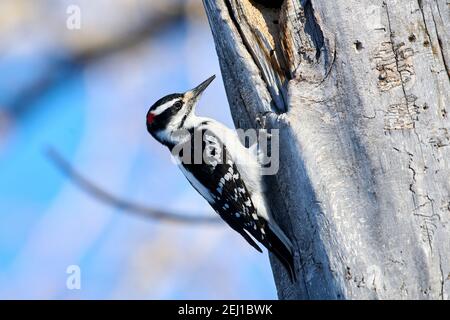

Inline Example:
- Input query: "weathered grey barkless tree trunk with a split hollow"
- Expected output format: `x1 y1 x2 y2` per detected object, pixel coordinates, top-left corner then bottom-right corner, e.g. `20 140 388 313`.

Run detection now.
204 0 450 299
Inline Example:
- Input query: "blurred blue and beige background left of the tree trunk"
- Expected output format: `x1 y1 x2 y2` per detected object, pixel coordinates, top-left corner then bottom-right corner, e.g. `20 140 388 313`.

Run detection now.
0 0 276 299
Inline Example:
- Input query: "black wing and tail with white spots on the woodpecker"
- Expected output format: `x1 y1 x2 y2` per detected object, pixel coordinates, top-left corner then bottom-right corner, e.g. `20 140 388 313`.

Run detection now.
175 130 295 280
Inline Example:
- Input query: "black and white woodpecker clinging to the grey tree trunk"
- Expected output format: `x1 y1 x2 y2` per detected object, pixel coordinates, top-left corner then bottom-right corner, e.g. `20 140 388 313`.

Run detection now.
147 76 296 281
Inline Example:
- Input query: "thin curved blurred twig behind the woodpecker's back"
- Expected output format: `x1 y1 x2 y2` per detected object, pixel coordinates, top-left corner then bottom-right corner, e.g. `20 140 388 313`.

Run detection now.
46 148 221 224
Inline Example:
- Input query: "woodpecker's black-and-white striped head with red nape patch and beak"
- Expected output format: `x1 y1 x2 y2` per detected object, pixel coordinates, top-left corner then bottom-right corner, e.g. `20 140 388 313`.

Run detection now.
147 75 216 145
